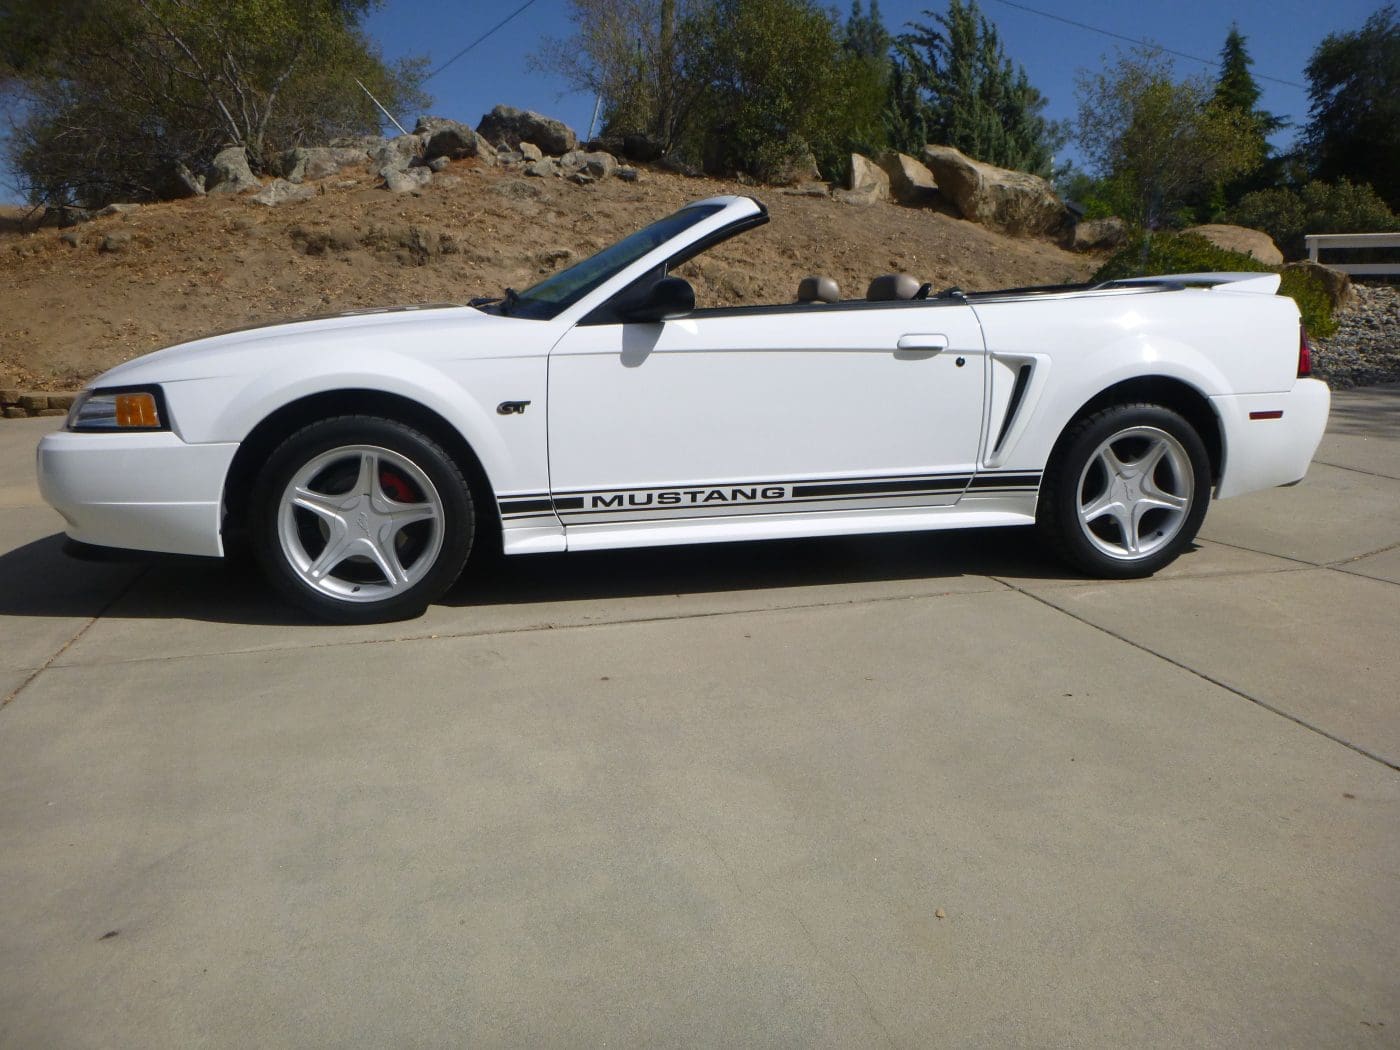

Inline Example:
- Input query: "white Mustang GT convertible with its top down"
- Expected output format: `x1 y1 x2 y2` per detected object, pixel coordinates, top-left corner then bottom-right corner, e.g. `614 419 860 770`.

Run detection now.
38 196 1329 622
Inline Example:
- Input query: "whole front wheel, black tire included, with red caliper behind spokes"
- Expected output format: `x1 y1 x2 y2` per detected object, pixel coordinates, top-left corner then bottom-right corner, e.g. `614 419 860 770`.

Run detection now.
249 416 476 623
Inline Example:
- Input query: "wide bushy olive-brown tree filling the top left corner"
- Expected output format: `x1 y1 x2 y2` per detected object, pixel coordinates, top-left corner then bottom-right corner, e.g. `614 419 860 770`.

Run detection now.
0 0 421 204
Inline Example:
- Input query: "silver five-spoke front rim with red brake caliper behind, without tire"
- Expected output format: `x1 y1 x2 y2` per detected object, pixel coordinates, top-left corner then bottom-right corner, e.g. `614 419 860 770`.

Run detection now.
277 445 442 602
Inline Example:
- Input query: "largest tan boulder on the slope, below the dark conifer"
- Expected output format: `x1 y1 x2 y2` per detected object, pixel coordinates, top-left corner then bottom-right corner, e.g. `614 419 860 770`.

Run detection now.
923 146 1070 237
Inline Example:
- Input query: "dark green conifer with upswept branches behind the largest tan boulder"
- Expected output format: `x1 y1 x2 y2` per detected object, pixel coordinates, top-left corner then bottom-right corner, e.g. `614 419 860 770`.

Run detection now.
888 0 1065 176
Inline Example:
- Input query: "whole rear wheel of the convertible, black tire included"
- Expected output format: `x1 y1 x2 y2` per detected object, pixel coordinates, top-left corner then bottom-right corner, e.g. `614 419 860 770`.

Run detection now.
1036 403 1211 580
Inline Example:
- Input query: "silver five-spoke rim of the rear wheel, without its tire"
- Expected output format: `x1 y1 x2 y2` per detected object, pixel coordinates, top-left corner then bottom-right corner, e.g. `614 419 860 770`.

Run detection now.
1078 427 1196 559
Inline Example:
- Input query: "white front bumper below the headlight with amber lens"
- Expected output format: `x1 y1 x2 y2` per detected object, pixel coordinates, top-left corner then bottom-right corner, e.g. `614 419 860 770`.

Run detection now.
36 431 238 557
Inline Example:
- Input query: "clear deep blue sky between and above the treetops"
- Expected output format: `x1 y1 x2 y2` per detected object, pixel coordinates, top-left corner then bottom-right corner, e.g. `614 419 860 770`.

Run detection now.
368 0 1380 163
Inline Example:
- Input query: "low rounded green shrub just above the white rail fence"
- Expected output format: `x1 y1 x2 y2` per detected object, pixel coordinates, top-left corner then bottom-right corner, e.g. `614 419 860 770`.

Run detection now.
1226 179 1400 259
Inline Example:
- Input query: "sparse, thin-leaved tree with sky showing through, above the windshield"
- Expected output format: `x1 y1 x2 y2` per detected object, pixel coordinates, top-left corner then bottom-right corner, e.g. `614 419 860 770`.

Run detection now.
532 0 707 153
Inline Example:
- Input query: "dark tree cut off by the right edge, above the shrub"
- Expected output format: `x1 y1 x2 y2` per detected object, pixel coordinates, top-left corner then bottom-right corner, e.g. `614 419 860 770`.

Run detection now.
1303 4 1400 211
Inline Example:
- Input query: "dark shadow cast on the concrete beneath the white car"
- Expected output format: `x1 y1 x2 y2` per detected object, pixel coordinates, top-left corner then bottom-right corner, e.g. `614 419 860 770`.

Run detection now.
0 528 1078 627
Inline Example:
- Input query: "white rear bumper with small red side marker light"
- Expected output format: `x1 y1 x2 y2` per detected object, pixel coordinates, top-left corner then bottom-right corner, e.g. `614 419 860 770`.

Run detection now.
1211 379 1331 498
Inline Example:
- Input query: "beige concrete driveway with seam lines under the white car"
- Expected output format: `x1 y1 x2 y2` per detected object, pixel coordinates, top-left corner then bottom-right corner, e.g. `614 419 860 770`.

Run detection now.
0 388 1400 1049
